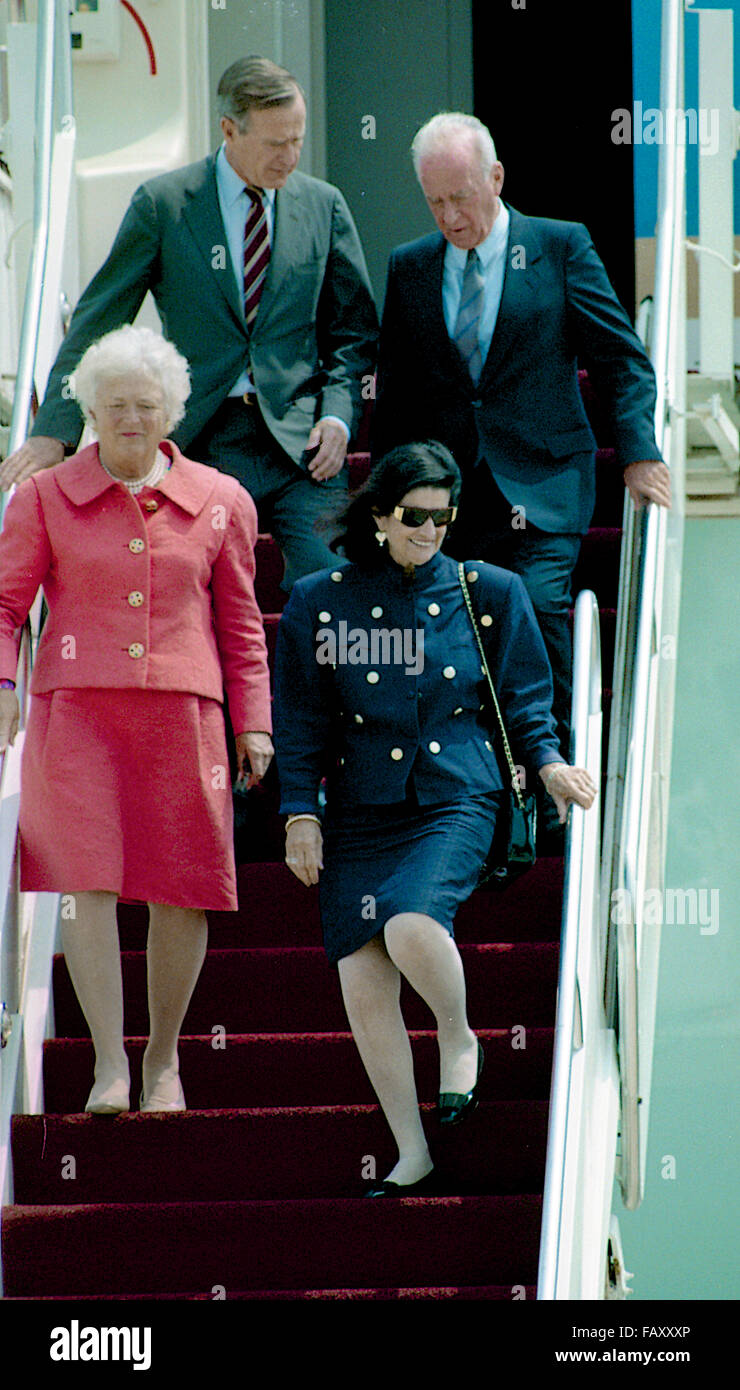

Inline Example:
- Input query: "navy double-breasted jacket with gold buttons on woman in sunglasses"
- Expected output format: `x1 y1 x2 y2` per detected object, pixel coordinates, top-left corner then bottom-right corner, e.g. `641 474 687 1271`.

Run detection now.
274 552 563 813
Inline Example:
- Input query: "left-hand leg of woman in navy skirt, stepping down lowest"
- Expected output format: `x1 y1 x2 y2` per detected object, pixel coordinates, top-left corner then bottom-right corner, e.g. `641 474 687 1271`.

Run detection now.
338 937 433 1183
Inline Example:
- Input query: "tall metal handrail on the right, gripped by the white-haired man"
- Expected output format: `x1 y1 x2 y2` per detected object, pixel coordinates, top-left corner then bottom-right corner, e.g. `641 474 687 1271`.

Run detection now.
602 0 684 1209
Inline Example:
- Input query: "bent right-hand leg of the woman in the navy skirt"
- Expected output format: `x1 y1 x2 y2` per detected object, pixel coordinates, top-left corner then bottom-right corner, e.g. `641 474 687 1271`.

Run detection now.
385 912 478 1094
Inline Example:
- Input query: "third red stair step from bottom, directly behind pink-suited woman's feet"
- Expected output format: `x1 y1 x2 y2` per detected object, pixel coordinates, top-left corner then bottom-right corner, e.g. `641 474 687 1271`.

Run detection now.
43 1024 552 1115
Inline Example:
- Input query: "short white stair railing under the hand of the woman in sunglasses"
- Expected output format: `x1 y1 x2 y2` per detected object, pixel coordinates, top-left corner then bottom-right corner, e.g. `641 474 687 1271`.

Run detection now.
537 589 619 1300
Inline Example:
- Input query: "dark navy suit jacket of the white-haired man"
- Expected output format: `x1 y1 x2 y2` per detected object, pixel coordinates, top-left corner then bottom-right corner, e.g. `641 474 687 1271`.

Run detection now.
373 209 661 534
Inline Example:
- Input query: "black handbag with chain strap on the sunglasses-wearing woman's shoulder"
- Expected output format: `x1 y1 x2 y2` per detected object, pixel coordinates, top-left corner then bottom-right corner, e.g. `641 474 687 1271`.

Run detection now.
458 563 537 888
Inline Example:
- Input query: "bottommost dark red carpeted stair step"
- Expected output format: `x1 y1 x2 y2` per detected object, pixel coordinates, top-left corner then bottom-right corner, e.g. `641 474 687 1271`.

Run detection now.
3 1189 541 1298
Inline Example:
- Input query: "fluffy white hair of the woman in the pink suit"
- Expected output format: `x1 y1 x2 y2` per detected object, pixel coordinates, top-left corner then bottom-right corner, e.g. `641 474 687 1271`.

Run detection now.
70 324 191 432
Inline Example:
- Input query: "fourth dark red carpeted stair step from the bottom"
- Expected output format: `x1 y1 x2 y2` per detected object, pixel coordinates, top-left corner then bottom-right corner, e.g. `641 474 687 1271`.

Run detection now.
53 941 559 1037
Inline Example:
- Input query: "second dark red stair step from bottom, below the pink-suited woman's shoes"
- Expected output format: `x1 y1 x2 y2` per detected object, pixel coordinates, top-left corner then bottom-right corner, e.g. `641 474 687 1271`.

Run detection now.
13 1098 548 1205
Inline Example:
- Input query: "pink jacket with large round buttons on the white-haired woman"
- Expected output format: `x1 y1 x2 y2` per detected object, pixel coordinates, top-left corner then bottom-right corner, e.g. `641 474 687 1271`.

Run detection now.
0 441 271 734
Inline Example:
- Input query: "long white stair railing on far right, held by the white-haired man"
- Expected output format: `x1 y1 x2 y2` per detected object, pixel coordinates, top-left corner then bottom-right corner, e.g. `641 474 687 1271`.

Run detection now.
602 0 686 1211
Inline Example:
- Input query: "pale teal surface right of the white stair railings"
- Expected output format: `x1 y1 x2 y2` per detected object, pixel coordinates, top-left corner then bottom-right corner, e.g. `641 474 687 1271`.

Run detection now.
612 517 740 1300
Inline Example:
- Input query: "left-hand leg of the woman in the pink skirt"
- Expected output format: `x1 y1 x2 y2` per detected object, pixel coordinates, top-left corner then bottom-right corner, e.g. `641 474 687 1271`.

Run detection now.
61 892 129 1111
